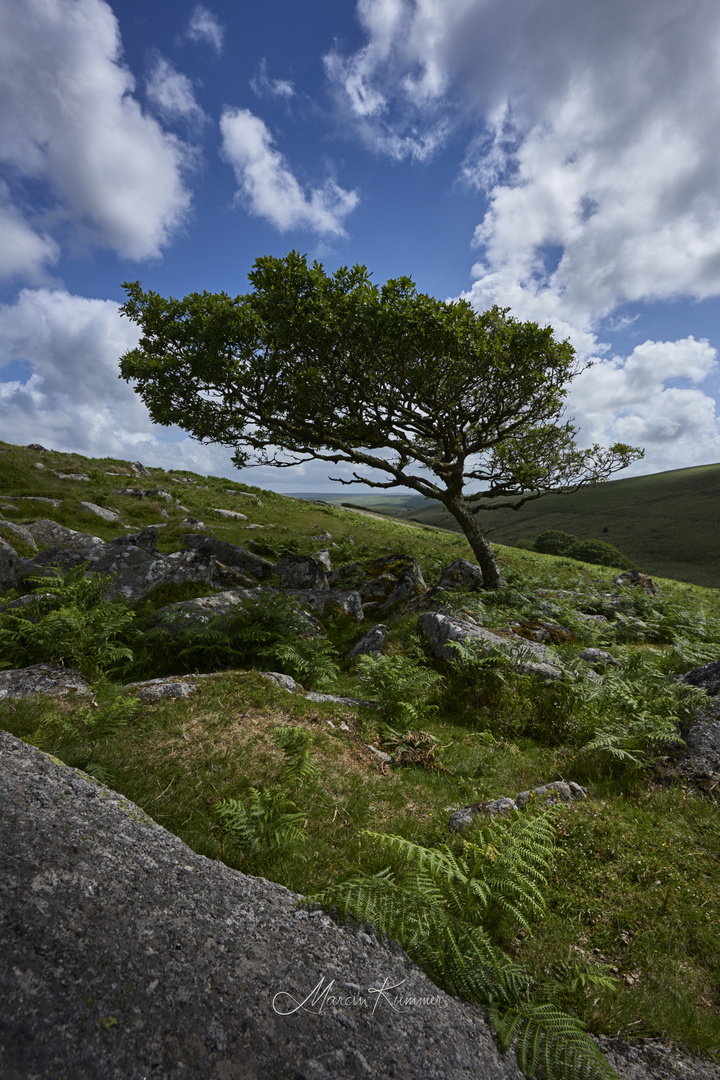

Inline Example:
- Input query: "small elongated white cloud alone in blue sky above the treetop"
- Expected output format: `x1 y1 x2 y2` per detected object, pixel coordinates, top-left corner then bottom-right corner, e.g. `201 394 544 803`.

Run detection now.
220 108 359 237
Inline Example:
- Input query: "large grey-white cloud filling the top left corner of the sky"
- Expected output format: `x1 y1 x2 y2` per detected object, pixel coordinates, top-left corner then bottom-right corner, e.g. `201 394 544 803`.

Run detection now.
0 0 192 276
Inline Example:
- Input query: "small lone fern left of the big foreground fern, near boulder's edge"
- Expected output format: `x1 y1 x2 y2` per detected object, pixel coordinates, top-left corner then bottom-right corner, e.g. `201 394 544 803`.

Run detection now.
215 787 305 875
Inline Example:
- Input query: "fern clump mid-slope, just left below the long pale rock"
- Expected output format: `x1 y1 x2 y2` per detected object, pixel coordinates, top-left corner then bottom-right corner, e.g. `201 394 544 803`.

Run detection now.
357 656 443 731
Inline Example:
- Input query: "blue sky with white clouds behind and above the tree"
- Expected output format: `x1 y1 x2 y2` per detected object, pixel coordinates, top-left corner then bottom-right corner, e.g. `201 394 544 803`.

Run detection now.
0 0 720 491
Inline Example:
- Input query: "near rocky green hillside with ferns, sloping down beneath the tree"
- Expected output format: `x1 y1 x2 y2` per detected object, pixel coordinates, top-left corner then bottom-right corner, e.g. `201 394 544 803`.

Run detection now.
0 443 720 1078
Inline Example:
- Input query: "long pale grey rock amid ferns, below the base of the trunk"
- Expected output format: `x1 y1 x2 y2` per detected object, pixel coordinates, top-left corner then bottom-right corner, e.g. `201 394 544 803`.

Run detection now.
418 611 562 679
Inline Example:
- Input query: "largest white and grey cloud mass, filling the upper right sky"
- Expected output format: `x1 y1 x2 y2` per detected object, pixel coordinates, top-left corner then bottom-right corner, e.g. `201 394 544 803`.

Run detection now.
326 0 720 336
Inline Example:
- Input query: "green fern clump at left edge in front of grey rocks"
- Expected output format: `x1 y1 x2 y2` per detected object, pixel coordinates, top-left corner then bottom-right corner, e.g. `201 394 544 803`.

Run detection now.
0 566 136 680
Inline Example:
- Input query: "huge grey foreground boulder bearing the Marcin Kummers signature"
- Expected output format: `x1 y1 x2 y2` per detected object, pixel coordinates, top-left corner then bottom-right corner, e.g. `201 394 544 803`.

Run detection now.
0 732 520 1080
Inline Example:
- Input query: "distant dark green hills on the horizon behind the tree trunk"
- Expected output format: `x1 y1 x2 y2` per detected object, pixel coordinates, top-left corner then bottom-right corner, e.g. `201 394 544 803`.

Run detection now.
294 464 720 589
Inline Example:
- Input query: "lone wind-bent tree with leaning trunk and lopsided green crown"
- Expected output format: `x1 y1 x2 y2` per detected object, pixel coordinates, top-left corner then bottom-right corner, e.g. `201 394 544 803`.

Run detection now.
121 252 642 588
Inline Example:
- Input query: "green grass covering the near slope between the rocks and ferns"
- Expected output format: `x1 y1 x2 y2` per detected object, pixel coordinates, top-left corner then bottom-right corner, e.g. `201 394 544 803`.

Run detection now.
0 444 720 1061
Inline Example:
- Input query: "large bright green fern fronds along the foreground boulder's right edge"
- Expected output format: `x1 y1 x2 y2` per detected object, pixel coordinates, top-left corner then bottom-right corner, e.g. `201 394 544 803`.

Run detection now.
303 810 616 1080
